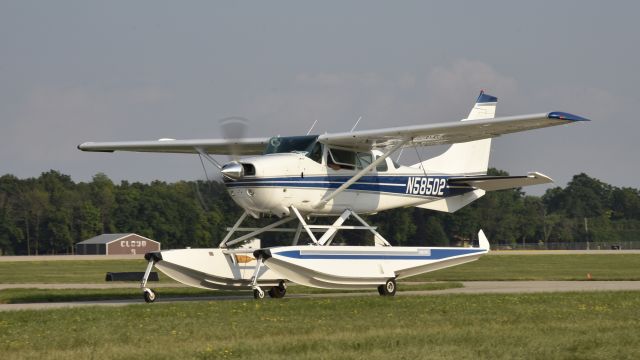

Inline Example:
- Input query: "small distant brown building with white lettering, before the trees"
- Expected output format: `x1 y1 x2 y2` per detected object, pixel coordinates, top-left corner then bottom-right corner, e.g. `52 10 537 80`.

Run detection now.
76 233 160 255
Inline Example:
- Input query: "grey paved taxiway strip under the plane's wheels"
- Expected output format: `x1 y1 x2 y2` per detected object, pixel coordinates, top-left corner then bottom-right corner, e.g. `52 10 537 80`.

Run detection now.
0 281 640 311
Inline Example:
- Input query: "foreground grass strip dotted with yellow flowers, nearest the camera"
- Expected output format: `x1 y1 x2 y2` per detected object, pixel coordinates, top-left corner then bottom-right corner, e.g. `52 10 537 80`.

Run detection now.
0 292 640 359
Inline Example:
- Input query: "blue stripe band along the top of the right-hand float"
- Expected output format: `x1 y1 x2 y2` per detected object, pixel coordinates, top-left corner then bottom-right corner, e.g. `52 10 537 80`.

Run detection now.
271 249 485 260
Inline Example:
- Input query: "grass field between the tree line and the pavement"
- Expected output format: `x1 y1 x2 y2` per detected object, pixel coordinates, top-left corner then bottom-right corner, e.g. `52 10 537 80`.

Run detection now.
0 254 640 284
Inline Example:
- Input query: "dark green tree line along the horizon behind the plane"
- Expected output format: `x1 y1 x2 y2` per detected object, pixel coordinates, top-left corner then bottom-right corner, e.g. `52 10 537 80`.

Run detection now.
0 169 640 255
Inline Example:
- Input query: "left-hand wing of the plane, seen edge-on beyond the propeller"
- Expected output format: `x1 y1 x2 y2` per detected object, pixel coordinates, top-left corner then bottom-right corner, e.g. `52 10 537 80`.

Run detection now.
78 138 269 155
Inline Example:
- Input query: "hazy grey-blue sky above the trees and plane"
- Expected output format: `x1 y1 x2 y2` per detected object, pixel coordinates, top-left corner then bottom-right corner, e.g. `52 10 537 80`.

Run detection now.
0 0 640 193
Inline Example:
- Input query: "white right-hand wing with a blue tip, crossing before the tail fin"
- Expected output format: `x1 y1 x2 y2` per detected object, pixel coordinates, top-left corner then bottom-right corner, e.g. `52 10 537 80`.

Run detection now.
318 111 589 150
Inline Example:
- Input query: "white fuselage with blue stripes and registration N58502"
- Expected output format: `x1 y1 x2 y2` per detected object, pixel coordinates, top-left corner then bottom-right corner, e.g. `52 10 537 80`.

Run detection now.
225 153 473 217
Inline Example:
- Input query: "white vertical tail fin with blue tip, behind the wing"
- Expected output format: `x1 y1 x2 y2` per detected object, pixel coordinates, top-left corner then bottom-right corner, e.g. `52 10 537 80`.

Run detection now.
412 91 498 175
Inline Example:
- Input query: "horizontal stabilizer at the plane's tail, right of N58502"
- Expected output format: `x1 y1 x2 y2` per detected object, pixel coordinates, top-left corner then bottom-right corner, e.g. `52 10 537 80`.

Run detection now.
447 172 553 191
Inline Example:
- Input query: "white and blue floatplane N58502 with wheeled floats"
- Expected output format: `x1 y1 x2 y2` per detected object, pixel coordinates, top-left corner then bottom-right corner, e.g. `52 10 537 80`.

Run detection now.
78 92 588 302
